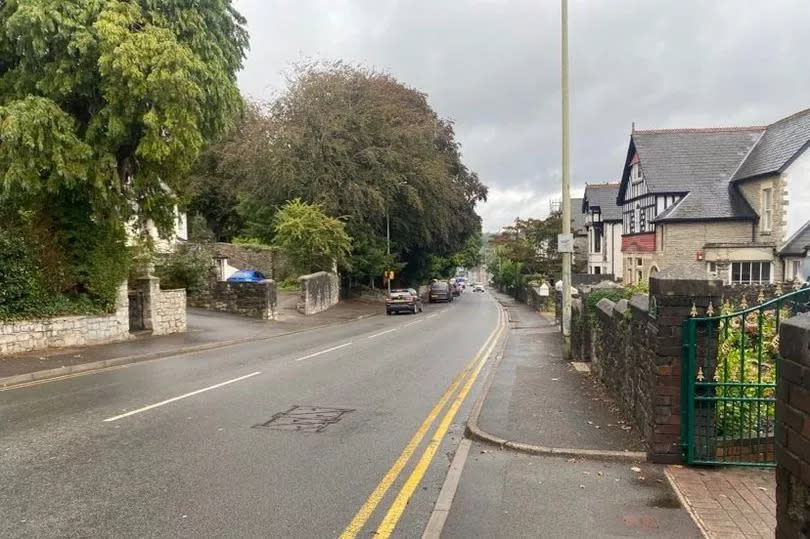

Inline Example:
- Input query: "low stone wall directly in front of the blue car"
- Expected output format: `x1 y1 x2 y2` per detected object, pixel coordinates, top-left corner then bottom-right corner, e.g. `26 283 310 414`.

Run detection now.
188 280 278 320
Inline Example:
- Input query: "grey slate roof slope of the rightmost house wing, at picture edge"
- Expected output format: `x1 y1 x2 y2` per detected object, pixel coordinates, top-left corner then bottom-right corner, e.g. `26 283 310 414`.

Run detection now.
733 109 810 181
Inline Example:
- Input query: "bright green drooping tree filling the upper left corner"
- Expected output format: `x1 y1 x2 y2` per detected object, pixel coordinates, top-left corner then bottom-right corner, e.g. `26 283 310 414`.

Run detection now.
0 0 248 307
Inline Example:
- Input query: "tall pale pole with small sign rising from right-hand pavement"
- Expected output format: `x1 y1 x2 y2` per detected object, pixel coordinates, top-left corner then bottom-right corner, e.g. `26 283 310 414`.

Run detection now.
561 0 571 359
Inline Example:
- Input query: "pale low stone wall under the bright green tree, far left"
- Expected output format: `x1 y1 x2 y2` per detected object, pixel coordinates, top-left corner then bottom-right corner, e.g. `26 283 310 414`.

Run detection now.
0 285 130 355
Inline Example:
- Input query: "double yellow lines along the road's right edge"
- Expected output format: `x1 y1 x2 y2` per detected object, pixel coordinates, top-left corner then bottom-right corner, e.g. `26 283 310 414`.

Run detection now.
340 306 506 539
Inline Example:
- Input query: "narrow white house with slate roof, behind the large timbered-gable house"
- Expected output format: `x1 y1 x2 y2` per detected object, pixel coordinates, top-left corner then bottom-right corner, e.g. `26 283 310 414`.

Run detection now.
582 183 623 279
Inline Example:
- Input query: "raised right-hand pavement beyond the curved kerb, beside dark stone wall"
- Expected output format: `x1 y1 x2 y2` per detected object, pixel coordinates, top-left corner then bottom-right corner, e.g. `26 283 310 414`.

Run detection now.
468 294 644 458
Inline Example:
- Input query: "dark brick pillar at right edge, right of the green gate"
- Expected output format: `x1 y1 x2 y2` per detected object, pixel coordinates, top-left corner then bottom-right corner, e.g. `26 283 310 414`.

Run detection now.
776 314 810 538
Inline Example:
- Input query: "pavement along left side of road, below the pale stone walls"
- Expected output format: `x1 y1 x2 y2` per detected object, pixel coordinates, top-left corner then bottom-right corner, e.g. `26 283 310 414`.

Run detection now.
0 294 383 386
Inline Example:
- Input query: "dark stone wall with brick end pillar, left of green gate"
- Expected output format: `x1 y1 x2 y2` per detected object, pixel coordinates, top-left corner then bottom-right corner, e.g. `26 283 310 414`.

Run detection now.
572 268 722 463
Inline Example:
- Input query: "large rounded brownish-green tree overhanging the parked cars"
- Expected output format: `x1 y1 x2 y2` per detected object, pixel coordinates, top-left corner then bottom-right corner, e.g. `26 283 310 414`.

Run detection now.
192 62 487 282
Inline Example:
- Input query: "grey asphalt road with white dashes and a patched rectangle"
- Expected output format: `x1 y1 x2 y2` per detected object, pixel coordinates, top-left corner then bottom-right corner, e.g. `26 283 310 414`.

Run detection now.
0 292 500 537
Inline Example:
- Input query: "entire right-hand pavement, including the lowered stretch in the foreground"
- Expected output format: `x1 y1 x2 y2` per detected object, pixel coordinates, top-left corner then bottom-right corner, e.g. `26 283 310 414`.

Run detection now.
436 294 701 539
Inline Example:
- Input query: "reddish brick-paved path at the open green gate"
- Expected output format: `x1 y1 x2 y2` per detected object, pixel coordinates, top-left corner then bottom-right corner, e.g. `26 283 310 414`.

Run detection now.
667 466 776 539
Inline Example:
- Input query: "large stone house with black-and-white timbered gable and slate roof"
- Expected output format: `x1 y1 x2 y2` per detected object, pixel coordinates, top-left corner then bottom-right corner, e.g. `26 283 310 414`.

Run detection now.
617 109 810 283
